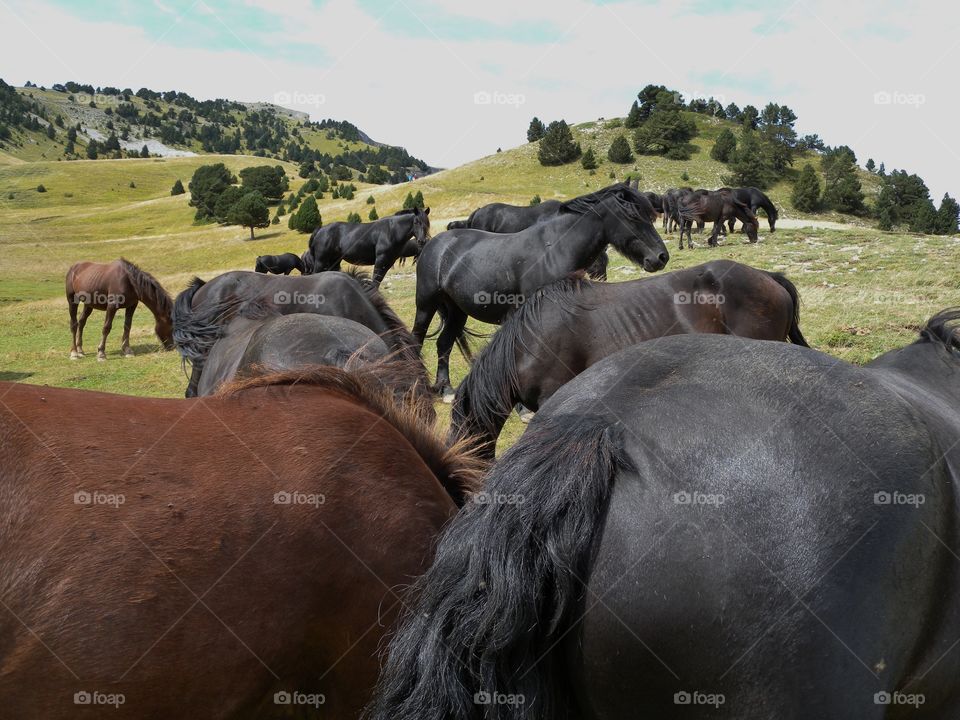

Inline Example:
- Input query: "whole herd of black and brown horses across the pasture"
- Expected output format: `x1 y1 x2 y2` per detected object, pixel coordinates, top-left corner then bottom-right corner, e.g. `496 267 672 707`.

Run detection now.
0 179 960 720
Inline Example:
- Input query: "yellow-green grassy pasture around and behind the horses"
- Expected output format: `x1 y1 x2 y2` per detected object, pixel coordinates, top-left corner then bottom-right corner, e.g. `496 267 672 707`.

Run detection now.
0 146 960 450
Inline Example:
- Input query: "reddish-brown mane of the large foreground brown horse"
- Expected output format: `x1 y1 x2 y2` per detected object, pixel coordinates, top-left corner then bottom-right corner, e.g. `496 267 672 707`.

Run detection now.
217 360 487 507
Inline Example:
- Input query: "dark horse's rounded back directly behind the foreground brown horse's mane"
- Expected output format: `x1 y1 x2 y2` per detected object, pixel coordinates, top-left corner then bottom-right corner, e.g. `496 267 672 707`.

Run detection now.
197 306 436 423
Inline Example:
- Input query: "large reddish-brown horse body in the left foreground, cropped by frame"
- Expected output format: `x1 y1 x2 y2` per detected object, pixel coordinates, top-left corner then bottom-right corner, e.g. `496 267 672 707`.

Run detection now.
0 367 482 720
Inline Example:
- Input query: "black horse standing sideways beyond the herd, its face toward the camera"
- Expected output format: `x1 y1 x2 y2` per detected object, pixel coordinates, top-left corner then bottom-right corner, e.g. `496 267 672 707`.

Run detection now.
309 208 430 285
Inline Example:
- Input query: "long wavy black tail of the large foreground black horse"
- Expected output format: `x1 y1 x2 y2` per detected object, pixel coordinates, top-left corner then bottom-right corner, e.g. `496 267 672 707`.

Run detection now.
367 415 630 720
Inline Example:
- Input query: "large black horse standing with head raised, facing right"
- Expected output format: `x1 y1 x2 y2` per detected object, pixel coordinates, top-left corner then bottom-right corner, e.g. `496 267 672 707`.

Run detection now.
413 184 670 399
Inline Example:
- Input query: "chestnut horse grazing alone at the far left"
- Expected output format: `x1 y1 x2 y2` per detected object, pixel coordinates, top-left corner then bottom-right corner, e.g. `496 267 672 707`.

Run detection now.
66 258 173 360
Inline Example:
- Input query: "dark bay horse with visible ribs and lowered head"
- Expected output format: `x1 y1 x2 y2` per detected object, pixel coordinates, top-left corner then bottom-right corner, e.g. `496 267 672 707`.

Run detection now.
450 260 808 458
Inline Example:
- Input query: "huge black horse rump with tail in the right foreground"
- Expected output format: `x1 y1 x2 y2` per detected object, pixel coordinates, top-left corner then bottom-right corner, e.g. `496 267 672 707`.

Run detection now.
369 310 960 720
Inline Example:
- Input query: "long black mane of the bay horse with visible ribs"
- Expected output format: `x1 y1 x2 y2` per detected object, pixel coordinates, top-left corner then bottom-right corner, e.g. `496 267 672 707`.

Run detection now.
450 271 594 456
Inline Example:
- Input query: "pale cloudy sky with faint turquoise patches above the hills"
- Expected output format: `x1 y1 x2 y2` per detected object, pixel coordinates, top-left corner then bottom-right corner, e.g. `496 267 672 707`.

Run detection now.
0 0 960 202
